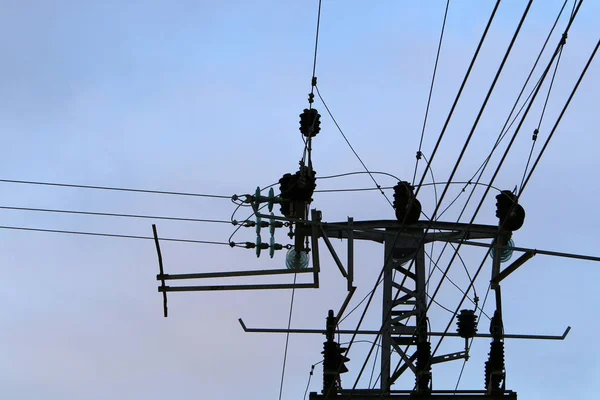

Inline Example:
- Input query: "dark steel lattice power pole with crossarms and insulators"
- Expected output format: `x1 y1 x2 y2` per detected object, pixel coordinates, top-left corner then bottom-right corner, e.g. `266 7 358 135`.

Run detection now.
154 105 572 400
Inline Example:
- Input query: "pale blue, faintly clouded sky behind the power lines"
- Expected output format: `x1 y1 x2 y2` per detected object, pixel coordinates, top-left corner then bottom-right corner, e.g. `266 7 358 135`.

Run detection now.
0 0 600 400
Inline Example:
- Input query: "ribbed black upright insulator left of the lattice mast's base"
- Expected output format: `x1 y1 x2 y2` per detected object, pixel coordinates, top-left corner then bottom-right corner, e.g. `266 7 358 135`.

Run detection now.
321 310 350 398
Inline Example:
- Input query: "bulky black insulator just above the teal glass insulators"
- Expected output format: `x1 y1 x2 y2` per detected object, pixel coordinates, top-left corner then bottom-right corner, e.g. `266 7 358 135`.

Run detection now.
279 165 317 219
